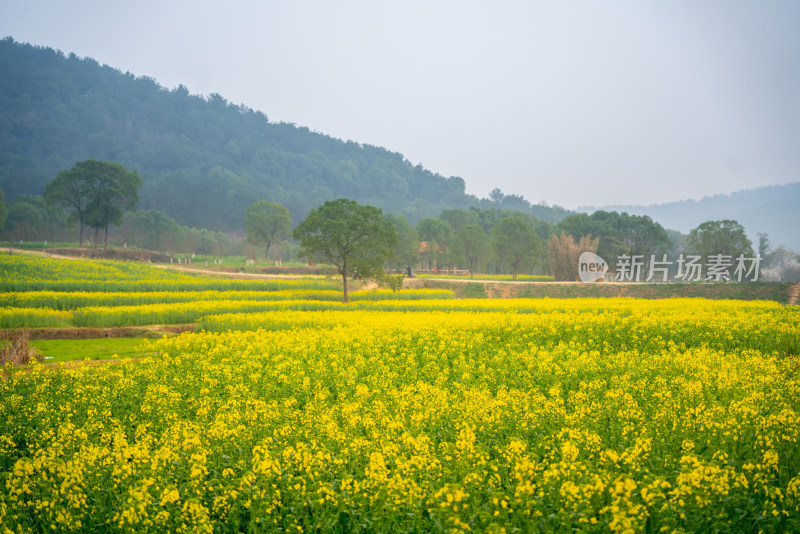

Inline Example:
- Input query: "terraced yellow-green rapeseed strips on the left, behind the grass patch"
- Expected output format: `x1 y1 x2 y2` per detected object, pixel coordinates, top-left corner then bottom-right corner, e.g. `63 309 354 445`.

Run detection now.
0 255 452 328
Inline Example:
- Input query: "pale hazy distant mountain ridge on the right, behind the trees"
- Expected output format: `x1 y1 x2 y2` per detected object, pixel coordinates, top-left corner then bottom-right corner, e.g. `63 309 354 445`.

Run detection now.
576 182 800 251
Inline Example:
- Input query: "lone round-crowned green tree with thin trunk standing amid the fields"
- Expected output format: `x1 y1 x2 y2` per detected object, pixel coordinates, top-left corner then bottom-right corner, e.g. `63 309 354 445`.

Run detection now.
292 198 397 303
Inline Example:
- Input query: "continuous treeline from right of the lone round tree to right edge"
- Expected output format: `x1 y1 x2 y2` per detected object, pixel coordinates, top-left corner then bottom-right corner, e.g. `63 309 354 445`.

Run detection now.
386 207 800 282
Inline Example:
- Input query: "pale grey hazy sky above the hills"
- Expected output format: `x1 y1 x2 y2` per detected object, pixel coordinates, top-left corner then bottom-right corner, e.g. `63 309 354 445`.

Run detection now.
0 0 800 208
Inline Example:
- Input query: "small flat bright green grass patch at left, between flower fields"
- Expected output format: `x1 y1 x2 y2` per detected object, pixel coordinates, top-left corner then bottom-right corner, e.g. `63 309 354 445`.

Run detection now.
31 338 147 363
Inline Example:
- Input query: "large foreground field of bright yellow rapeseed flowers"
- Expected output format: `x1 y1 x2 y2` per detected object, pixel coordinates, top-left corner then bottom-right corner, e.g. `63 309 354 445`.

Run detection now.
0 254 800 533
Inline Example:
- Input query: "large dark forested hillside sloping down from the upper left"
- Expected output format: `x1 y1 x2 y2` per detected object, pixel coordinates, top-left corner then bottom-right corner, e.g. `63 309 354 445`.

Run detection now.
0 38 568 230
